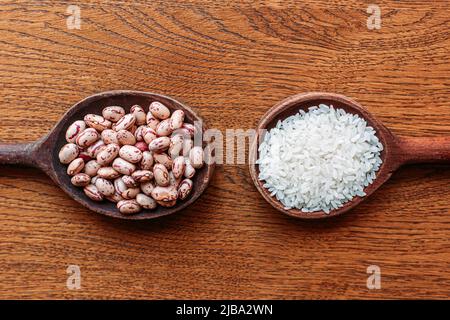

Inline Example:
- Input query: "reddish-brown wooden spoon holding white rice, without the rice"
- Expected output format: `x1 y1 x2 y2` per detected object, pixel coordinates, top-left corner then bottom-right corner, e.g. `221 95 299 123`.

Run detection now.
249 92 450 219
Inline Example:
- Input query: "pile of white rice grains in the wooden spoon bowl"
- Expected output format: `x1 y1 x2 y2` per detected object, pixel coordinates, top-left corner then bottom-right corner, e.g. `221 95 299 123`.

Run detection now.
257 104 383 213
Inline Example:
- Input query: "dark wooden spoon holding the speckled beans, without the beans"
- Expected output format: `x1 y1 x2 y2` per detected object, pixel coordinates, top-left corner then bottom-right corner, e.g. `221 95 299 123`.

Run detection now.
0 90 214 220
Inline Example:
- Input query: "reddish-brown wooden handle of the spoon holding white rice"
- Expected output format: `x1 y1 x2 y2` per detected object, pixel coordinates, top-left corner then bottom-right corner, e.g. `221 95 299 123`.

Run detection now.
400 136 450 163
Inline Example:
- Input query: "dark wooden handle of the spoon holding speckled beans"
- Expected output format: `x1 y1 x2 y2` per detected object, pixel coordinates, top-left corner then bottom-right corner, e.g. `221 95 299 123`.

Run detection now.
0 142 36 167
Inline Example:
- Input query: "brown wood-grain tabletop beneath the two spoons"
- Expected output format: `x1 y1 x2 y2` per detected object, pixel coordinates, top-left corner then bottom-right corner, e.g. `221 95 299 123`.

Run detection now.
0 0 450 299
